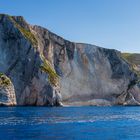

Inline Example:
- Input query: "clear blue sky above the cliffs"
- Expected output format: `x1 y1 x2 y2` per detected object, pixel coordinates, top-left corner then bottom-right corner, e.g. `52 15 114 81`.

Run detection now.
0 0 140 53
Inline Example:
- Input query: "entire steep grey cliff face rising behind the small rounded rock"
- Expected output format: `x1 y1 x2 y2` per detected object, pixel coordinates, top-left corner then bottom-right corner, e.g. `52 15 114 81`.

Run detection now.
0 15 140 106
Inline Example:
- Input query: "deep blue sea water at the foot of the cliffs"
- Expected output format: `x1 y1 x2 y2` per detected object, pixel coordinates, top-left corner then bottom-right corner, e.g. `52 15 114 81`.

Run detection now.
0 106 140 140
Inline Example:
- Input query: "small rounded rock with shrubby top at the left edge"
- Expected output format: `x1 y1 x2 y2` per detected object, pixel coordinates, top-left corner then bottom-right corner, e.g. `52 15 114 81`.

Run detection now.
0 73 16 106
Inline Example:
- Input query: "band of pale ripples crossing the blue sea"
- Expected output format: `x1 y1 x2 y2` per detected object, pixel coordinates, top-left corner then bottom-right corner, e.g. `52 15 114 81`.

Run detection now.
0 114 140 126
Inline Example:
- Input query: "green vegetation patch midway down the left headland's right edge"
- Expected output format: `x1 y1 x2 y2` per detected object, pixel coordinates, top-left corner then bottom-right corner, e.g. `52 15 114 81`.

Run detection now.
40 58 59 86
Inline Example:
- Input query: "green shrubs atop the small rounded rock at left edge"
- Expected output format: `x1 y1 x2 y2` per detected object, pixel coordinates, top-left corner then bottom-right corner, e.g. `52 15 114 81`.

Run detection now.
0 73 11 86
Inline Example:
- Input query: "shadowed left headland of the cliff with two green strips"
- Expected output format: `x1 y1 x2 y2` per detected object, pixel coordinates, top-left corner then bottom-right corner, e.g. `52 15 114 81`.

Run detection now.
0 15 59 106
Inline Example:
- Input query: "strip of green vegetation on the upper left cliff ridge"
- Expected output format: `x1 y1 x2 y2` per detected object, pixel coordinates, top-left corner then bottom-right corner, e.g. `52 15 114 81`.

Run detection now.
9 16 37 45
